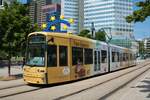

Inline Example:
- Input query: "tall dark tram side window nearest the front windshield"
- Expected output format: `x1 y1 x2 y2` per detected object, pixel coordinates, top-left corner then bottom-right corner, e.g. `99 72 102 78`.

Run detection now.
47 45 57 67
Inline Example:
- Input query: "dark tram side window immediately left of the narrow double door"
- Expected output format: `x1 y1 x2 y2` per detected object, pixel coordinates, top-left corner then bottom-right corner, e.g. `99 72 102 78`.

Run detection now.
84 49 93 64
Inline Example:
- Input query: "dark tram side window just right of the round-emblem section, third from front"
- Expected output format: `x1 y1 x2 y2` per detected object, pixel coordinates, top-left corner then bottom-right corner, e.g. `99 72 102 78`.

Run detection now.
72 47 83 65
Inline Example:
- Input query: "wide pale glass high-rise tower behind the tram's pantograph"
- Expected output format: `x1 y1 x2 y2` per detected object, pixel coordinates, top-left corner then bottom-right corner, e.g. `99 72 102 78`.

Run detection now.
84 0 133 37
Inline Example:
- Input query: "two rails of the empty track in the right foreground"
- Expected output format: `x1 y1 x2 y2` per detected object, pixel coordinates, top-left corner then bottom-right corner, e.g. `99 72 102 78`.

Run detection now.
54 63 150 100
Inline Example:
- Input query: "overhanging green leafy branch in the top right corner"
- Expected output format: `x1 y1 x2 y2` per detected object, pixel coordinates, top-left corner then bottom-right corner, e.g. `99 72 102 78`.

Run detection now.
126 0 150 23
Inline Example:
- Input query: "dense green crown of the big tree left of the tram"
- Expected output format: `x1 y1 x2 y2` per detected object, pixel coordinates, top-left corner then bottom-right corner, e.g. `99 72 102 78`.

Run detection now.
0 1 38 57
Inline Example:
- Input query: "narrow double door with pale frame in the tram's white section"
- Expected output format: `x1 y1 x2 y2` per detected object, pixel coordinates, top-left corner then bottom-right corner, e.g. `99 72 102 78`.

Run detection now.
94 50 100 71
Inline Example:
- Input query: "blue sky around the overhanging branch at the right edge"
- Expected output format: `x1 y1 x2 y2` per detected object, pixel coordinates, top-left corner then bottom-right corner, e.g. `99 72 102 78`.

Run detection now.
133 0 150 40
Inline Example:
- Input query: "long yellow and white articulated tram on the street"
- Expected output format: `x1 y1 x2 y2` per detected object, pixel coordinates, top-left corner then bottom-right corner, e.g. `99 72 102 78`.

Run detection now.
23 32 135 84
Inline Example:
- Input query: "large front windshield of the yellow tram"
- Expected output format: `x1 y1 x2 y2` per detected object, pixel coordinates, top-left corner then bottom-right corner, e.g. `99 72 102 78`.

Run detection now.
26 34 45 67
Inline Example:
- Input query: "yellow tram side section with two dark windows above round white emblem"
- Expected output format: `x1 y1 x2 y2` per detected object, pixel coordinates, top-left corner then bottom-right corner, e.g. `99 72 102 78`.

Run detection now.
47 45 70 83
